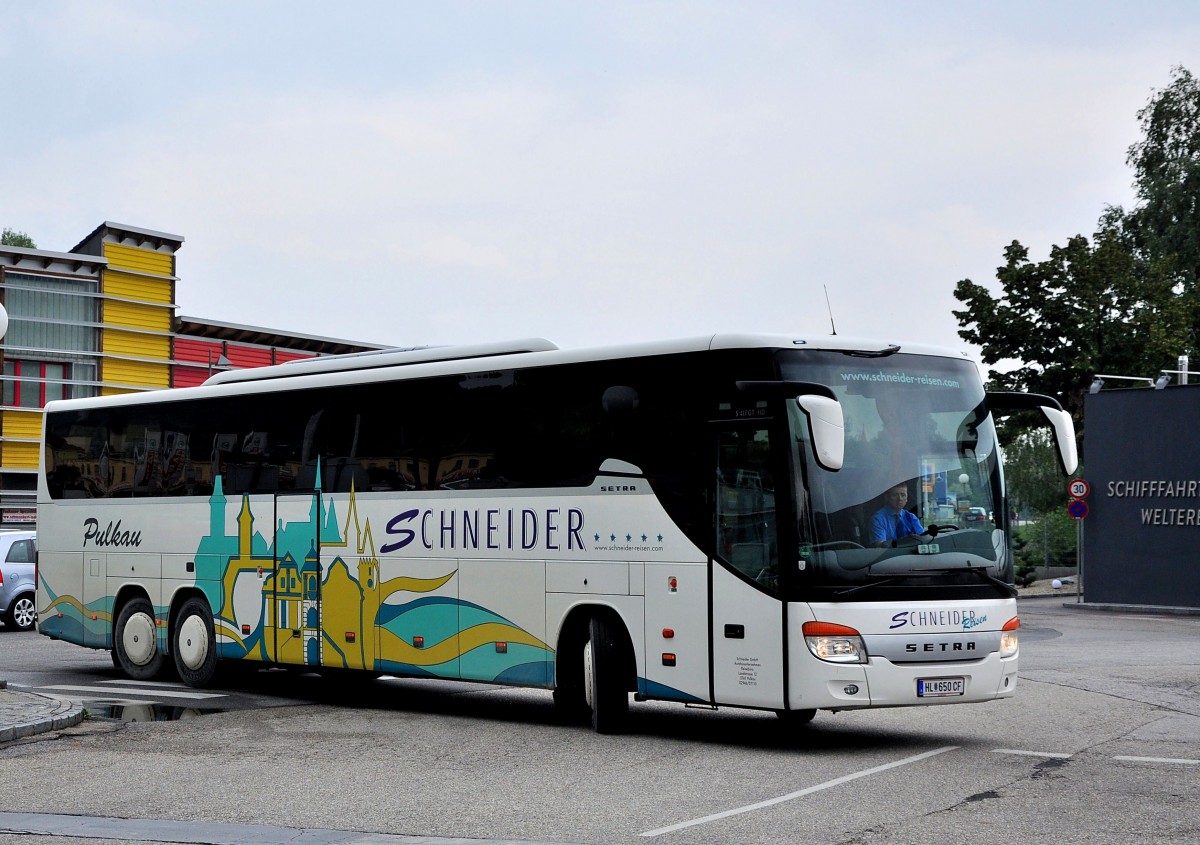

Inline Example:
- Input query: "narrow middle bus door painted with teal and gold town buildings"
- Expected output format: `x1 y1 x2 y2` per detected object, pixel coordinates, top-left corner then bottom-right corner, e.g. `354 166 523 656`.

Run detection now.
269 492 322 666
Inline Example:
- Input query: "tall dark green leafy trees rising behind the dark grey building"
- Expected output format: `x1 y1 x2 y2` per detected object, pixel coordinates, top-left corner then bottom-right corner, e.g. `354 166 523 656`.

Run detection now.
954 67 1200 437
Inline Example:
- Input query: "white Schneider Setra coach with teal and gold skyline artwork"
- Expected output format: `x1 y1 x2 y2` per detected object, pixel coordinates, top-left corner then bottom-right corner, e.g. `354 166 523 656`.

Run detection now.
37 335 1076 732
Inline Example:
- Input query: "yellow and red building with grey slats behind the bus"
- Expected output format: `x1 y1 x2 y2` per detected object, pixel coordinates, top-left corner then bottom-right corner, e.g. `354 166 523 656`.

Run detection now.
0 222 380 527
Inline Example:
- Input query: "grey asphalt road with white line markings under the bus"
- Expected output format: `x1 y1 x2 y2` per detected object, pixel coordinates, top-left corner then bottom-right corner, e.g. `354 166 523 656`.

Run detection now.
0 598 1200 845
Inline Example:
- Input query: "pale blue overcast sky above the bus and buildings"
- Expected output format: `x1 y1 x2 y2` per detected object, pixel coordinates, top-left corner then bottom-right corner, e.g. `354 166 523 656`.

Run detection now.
0 0 1200 352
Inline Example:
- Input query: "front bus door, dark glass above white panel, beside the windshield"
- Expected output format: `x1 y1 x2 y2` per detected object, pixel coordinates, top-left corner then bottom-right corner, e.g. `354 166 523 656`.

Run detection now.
709 420 787 709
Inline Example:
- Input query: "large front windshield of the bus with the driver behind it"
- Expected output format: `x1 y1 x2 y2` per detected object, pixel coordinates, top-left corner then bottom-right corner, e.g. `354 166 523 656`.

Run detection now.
780 350 1013 587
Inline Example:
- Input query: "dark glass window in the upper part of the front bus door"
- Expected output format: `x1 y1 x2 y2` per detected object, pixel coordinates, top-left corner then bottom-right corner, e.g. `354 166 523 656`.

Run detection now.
716 429 779 589
